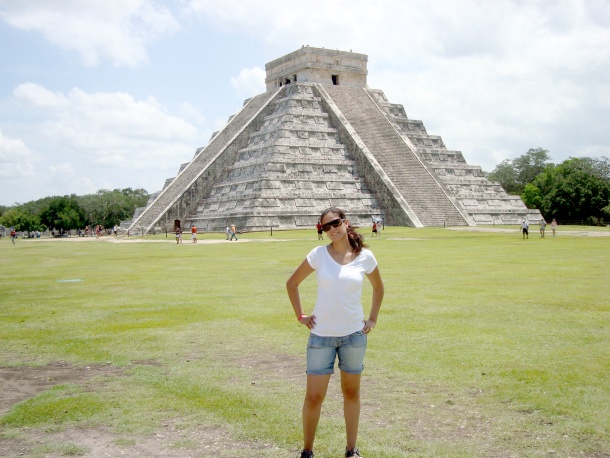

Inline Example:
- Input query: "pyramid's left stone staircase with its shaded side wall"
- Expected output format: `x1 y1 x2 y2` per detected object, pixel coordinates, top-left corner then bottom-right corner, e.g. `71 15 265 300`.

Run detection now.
128 89 281 232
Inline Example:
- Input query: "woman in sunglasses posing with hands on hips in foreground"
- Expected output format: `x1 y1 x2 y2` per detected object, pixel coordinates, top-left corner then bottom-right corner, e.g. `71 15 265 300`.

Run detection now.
286 208 383 458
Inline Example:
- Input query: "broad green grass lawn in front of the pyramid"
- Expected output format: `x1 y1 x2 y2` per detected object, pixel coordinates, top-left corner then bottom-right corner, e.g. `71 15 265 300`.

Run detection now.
0 225 610 458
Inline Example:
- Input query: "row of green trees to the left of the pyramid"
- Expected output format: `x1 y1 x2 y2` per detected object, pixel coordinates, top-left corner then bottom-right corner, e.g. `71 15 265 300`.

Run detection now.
0 188 148 232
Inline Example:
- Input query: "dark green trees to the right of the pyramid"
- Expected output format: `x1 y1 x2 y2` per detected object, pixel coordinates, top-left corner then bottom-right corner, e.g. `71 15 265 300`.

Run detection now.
487 148 610 225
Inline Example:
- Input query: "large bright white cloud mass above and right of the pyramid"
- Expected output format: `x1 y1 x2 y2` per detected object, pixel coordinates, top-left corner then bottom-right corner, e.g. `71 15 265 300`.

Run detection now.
188 0 610 170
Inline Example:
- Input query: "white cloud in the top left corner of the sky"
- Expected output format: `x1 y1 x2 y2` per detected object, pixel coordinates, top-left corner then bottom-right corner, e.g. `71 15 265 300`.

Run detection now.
0 0 179 67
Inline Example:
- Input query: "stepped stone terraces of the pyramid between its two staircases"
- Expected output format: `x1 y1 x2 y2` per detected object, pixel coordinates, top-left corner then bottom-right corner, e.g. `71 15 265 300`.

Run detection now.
188 83 383 231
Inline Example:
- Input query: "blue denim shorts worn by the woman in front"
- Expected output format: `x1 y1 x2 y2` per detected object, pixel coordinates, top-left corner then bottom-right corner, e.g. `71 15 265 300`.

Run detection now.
307 331 367 375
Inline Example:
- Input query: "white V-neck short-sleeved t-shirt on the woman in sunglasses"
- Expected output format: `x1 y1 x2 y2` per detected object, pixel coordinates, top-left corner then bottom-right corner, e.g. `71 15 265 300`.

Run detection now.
307 246 377 337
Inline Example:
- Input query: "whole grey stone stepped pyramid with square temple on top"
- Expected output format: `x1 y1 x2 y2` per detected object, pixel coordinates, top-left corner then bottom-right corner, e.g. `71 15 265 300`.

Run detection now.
124 46 540 232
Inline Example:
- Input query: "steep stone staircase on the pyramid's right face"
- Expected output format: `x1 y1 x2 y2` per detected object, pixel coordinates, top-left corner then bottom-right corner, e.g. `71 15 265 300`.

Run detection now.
323 85 471 226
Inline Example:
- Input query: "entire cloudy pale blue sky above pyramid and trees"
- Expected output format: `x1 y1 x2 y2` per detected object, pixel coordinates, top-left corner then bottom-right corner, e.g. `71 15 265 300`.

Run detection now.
0 0 610 205
